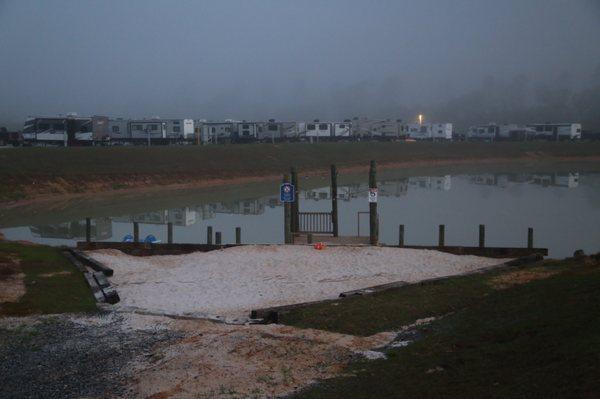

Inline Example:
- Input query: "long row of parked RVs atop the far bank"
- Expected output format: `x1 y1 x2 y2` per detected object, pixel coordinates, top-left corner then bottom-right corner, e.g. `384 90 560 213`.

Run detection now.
17 115 581 144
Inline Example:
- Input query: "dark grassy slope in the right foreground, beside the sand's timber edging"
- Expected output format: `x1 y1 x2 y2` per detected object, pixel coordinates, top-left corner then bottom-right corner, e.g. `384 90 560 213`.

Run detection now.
283 255 600 398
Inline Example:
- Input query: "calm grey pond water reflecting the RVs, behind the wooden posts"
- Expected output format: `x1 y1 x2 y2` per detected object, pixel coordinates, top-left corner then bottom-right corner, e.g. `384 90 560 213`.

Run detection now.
0 171 600 257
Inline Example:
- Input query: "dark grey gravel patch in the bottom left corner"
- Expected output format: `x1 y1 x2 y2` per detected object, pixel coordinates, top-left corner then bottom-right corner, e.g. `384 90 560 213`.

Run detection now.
0 314 180 399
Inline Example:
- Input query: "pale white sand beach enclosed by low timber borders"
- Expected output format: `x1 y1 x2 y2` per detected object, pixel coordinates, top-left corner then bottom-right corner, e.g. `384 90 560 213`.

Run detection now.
88 245 506 319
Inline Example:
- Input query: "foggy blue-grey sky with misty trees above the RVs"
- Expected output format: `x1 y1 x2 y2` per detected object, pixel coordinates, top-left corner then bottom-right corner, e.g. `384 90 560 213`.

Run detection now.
0 0 600 130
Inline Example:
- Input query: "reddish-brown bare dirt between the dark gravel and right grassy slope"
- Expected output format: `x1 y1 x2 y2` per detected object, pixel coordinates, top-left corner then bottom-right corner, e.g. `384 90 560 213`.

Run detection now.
130 316 396 398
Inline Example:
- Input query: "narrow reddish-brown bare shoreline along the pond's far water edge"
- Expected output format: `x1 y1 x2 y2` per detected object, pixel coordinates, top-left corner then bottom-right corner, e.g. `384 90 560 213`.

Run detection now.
0 154 600 210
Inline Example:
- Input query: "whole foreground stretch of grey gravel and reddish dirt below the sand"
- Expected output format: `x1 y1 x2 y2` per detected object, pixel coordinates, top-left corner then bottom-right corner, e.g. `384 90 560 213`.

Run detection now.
0 312 397 399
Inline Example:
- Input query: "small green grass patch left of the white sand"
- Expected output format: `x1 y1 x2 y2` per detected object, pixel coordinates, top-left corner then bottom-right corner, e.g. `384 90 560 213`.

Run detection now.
0 243 96 316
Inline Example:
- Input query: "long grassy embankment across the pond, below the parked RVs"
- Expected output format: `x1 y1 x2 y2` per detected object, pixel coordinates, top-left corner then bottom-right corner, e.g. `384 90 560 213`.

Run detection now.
0 142 600 203
